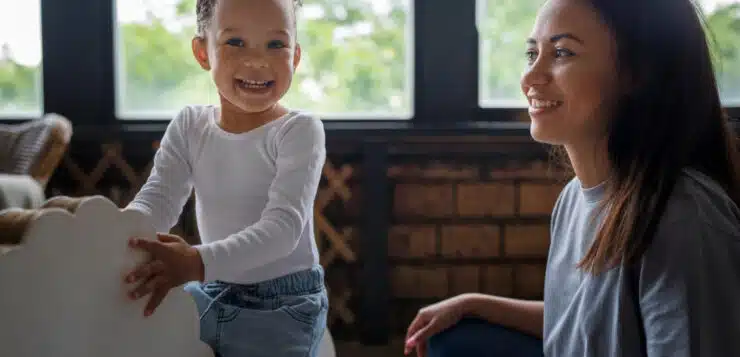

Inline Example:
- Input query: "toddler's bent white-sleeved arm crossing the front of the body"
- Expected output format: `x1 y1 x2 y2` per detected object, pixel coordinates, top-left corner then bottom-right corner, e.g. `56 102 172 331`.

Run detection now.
196 117 326 281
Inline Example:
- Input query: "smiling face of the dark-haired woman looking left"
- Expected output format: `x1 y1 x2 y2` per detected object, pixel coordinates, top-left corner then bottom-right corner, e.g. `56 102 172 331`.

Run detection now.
521 0 618 145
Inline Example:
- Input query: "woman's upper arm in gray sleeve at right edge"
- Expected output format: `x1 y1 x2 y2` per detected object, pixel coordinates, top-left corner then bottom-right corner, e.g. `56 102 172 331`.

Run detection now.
636 200 740 357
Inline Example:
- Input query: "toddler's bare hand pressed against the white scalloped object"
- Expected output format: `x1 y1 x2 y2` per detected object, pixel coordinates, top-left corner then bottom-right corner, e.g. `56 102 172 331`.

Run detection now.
125 234 204 316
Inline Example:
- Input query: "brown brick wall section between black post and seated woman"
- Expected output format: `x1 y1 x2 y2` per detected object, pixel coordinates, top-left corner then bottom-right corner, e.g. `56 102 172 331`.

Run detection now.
388 158 568 333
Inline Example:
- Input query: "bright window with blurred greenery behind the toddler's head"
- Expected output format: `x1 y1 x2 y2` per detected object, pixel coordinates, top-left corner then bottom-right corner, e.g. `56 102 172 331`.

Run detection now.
116 0 413 119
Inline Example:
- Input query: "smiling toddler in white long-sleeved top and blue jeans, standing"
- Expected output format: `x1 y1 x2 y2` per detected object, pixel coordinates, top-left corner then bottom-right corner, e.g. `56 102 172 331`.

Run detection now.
125 0 328 357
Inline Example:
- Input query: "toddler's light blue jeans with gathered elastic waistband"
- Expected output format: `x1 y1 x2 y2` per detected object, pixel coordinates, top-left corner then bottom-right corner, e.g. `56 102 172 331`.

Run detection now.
185 265 329 357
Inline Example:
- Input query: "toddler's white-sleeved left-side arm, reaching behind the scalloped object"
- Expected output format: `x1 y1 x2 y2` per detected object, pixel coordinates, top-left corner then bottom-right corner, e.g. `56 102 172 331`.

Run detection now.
127 108 193 233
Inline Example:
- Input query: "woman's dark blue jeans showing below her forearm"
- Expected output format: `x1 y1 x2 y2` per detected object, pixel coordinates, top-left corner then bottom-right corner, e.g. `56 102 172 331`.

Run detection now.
427 319 544 357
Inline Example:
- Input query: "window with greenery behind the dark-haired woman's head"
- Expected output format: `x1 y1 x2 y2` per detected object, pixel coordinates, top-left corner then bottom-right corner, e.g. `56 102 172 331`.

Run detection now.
478 0 740 108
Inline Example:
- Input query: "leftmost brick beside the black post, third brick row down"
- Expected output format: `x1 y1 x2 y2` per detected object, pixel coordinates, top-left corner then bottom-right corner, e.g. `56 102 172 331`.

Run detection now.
388 225 437 258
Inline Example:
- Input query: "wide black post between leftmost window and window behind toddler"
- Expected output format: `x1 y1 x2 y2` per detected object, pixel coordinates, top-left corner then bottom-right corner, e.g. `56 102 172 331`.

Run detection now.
41 0 115 128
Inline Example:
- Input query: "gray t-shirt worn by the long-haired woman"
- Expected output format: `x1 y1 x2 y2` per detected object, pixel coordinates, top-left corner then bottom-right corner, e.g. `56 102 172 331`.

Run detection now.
544 170 740 357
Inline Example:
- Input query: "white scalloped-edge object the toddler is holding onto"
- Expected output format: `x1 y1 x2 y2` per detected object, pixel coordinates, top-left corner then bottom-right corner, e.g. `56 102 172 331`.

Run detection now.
0 196 213 357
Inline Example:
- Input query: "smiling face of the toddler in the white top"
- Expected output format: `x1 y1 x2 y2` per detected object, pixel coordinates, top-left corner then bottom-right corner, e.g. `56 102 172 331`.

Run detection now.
193 0 300 113
